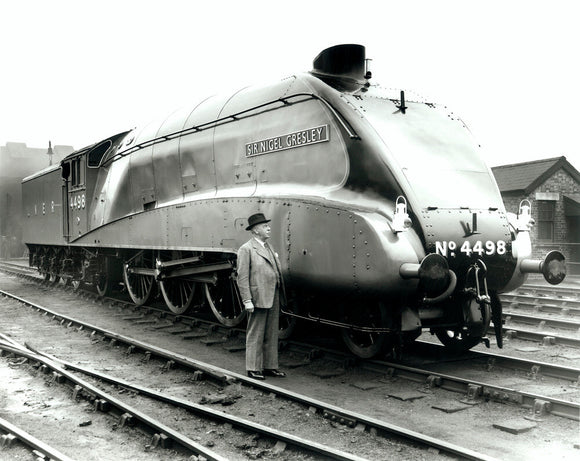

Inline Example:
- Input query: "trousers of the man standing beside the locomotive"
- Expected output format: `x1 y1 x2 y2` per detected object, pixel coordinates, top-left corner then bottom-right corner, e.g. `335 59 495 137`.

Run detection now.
246 288 280 371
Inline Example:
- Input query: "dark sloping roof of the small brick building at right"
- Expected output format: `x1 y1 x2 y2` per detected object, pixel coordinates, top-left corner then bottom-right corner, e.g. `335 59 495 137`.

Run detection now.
491 156 580 194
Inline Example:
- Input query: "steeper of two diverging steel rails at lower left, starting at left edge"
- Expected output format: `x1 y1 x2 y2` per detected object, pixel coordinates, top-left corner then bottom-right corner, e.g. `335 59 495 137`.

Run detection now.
0 340 227 461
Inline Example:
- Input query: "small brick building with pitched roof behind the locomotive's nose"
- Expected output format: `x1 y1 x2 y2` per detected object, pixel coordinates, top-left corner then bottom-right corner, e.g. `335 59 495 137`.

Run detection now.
492 157 580 275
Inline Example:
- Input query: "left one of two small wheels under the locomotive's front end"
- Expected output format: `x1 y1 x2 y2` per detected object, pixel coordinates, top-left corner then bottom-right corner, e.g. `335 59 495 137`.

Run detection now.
341 302 387 359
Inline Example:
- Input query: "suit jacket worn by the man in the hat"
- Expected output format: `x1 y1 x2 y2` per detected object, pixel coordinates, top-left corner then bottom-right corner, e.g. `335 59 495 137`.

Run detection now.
237 238 285 308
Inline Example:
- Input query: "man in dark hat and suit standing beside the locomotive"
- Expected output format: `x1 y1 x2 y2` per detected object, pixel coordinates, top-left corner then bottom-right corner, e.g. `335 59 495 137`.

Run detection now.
238 213 286 379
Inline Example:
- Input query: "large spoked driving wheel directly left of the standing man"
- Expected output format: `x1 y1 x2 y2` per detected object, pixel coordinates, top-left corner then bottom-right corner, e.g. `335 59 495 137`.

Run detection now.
205 274 246 327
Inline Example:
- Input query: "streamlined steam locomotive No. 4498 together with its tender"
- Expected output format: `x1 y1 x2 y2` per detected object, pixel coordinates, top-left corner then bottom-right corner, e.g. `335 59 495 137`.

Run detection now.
23 45 565 357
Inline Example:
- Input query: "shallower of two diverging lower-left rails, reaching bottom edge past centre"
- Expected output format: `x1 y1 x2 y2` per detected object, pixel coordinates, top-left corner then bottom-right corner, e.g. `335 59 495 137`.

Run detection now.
26 344 364 461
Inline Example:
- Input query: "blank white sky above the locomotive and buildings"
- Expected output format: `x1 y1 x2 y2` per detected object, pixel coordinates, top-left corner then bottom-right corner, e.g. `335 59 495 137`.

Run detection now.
0 0 580 169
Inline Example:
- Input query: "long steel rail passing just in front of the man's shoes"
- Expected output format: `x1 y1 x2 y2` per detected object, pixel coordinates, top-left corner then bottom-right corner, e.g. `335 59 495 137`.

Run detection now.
0 290 495 461
